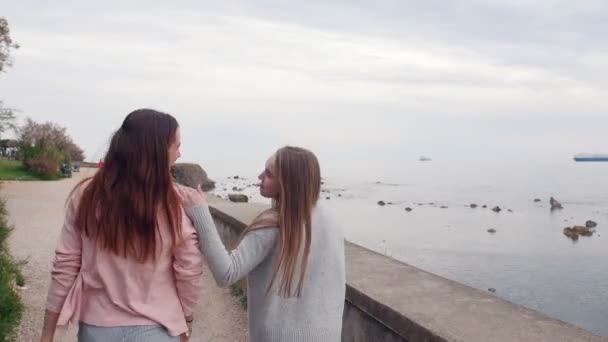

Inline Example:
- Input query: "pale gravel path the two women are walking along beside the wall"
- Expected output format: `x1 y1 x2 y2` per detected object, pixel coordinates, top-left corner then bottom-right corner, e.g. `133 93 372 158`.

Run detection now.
0 169 247 342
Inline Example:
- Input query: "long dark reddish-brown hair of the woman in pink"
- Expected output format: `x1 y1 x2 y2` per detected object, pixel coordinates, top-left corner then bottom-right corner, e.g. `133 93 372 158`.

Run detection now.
76 109 181 262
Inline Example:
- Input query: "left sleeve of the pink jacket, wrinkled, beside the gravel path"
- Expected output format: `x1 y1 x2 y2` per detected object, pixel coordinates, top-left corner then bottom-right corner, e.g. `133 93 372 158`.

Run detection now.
46 190 82 313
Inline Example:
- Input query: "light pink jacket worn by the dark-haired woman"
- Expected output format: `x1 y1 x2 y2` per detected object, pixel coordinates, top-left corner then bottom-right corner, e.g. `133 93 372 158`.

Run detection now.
47 186 202 336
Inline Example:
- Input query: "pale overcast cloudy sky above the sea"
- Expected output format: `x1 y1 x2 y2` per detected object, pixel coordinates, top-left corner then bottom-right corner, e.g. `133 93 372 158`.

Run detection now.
0 0 608 179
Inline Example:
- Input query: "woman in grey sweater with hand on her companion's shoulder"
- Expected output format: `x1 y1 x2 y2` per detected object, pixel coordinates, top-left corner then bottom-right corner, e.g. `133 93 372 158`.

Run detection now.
180 146 345 342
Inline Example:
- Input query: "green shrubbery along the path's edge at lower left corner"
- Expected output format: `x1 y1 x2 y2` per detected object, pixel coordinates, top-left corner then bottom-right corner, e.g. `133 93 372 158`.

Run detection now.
0 194 25 342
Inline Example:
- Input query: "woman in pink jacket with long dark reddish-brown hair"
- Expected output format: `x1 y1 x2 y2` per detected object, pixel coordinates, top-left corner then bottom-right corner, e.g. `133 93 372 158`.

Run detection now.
41 109 202 342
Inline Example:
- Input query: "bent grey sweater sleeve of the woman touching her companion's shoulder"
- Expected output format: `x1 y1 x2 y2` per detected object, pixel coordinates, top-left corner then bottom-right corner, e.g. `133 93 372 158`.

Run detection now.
186 205 279 286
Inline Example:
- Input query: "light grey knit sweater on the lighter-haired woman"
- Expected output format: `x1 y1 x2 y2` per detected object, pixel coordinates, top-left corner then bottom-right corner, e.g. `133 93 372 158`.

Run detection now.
187 205 346 342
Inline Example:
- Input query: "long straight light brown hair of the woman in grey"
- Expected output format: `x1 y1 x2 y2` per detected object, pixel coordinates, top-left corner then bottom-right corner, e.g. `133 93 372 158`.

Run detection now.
248 146 321 297
